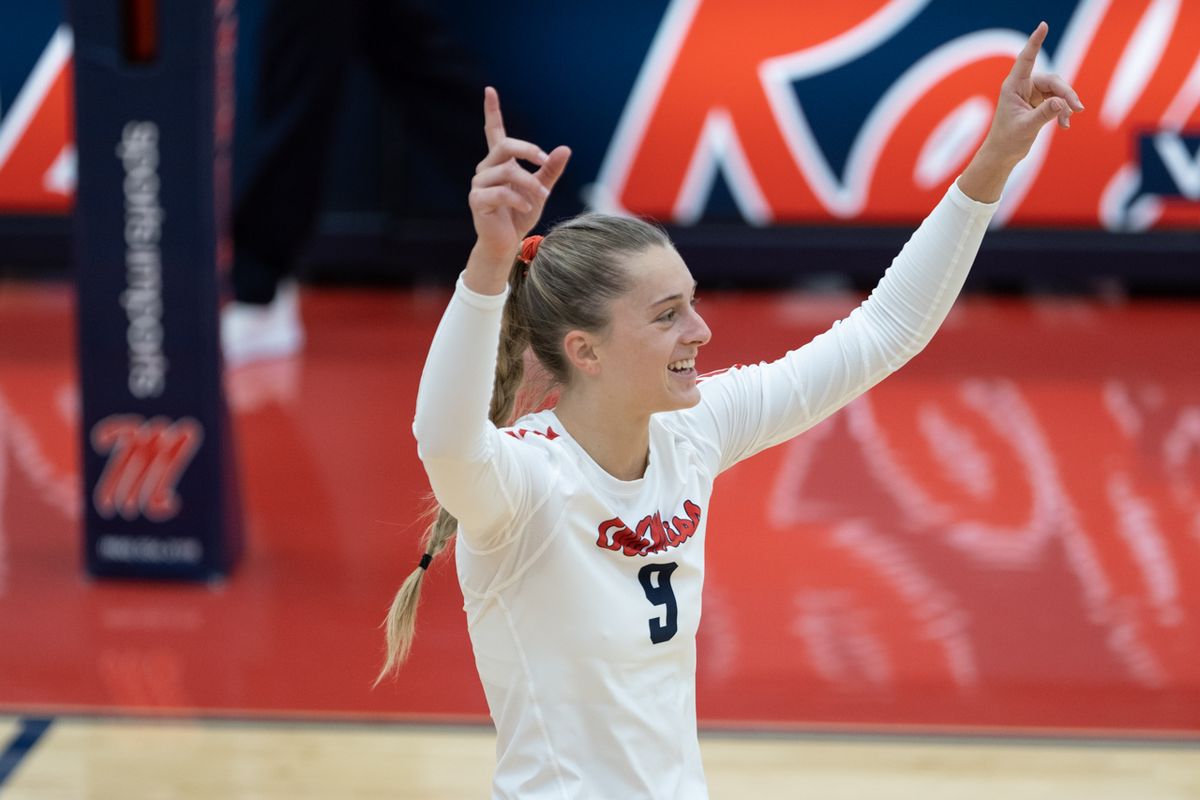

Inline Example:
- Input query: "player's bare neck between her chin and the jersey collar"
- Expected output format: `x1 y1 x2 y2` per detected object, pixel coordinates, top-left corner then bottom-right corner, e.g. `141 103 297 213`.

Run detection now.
554 390 650 481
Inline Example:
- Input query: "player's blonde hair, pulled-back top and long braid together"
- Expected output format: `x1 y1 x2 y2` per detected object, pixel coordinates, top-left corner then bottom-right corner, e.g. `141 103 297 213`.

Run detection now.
376 213 672 685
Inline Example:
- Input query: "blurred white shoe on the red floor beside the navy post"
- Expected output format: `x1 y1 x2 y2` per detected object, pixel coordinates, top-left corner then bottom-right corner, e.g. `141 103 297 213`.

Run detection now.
221 281 305 367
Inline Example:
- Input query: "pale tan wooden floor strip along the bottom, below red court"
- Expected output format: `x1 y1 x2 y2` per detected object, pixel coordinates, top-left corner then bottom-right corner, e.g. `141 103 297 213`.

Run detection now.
0 717 1200 800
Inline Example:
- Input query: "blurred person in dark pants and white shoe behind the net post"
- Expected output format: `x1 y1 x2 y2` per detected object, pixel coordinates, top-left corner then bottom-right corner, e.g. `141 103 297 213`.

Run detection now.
221 0 480 365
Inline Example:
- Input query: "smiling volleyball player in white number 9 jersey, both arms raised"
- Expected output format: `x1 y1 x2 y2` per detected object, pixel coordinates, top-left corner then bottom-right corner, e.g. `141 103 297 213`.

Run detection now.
383 23 1084 800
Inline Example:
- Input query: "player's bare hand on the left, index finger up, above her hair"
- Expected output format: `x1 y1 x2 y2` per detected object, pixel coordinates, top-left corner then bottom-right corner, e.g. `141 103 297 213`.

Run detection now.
468 86 571 263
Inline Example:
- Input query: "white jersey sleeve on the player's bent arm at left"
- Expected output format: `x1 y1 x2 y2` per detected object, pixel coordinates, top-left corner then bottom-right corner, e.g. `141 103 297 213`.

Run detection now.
413 277 539 549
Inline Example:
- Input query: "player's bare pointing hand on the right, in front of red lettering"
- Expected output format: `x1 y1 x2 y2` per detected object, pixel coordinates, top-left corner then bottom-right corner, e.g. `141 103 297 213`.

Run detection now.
980 22 1084 166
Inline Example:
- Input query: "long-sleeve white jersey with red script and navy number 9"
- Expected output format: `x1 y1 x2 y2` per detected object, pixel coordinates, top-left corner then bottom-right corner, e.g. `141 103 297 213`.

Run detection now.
413 185 995 800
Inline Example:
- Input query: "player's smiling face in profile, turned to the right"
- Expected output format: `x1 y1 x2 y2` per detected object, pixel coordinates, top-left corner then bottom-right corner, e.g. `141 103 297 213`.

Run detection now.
568 246 712 416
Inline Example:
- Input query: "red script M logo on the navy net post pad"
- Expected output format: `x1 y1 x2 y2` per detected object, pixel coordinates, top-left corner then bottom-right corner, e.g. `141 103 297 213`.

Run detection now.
91 414 204 522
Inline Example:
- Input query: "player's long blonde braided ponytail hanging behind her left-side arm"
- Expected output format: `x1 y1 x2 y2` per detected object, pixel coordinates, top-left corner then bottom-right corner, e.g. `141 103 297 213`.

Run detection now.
374 258 529 686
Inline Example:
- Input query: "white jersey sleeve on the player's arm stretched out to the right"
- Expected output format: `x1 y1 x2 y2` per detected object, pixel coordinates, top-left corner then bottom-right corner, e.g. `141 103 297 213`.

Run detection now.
686 182 997 471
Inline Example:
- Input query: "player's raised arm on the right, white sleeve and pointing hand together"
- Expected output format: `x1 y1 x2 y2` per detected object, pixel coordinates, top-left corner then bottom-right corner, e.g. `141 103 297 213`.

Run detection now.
686 23 1084 470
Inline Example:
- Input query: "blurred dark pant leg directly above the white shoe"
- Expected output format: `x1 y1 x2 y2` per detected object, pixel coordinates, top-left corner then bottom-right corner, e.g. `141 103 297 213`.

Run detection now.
232 0 362 303
